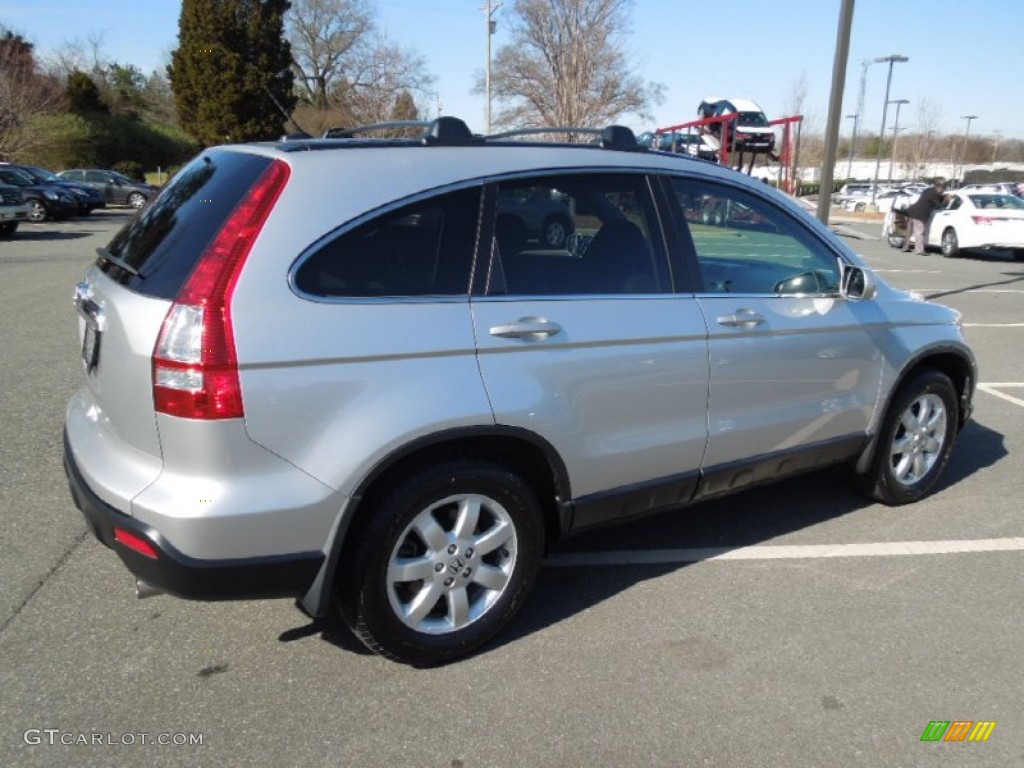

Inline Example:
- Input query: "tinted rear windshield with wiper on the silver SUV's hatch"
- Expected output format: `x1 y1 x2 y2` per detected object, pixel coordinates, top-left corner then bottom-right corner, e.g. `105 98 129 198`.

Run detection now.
97 151 270 299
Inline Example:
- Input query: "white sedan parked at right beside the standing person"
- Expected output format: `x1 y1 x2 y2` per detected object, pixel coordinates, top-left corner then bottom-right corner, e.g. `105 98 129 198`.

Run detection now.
926 190 1024 261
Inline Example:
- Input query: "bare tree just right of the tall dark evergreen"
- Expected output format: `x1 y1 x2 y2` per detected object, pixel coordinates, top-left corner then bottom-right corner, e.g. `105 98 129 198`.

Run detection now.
288 0 433 132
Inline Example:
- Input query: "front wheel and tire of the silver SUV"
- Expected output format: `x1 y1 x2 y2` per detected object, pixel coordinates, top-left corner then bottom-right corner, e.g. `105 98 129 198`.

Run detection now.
858 371 959 506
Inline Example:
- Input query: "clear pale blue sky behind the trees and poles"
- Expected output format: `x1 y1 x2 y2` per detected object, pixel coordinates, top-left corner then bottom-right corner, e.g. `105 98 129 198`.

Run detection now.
0 0 1024 143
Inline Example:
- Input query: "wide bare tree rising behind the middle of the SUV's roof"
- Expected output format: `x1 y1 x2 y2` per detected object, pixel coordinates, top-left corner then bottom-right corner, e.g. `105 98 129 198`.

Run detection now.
487 0 664 128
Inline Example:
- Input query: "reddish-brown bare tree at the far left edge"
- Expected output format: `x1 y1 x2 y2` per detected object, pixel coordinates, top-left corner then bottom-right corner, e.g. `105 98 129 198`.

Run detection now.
0 28 63 160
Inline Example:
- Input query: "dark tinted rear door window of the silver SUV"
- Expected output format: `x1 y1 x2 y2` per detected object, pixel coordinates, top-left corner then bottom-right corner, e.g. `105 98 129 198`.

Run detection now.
487 174 669 296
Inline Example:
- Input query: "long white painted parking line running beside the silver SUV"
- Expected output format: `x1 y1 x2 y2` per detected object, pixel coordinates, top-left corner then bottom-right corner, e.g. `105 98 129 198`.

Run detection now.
545 537 1024 567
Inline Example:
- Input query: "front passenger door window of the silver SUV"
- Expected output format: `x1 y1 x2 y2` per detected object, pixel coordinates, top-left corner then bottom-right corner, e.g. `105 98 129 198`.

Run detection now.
673 179 840 295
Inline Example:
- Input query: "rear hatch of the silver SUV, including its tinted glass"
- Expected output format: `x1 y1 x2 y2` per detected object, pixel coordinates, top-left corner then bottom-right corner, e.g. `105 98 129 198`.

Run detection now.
68 151 271 511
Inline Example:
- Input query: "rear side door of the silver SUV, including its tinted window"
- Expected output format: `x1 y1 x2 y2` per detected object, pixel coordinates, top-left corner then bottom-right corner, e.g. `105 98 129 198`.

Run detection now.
472 172 708 527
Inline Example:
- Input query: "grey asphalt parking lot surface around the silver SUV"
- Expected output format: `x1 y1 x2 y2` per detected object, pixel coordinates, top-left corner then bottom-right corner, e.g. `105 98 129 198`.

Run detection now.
0 211 1024 768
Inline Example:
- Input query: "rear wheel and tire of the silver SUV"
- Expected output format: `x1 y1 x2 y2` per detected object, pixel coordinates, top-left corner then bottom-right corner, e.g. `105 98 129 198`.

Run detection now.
336 459 544 667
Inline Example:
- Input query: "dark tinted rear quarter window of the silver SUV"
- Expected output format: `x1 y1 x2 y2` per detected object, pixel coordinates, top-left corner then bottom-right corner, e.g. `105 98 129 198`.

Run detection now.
295 188 480 297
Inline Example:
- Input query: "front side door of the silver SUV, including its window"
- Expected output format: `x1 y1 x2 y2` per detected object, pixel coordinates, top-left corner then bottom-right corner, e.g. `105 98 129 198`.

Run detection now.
670 178 882 494
